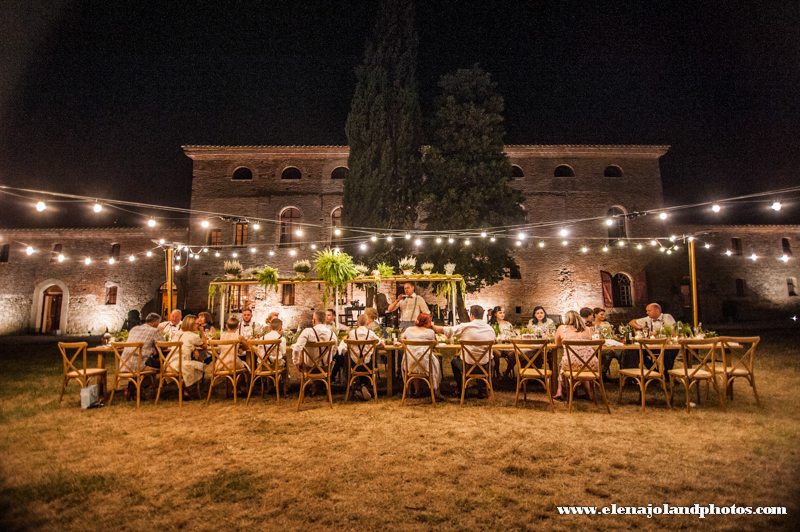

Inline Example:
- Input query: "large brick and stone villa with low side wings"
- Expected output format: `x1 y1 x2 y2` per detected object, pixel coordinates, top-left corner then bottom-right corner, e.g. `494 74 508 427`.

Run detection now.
0 145 800 334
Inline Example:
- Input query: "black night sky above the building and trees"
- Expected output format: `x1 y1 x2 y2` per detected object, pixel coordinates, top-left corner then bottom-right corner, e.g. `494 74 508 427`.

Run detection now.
0 1 800 227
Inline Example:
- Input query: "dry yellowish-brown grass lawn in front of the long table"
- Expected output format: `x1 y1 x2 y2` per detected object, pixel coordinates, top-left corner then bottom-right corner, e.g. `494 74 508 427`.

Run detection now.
0 332 800 531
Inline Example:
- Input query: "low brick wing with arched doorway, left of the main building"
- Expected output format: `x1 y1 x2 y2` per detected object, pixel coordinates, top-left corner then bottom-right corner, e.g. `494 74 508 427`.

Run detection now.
0 228 186 334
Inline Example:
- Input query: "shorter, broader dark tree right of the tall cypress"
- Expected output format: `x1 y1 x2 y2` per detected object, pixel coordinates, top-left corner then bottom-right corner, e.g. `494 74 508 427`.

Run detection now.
420 65 525 292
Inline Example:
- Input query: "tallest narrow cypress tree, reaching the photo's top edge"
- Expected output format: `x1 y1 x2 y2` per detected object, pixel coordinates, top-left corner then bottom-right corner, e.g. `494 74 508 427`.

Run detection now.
342 0 422 235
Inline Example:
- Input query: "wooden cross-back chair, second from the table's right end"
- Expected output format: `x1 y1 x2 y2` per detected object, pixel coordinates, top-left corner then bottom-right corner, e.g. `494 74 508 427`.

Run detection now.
668 338 725 412
